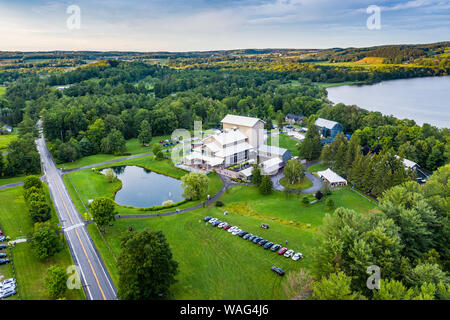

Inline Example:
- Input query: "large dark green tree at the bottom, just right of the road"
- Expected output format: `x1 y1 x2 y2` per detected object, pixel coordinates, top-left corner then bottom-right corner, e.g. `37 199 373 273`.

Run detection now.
118 230 178 300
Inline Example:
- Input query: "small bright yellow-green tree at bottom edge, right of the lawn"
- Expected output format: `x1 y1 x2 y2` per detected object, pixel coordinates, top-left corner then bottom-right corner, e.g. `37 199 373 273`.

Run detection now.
311 272 360 300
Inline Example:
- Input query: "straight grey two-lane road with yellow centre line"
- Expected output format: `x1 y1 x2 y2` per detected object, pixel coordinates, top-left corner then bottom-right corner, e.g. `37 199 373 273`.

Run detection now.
36 122 116 300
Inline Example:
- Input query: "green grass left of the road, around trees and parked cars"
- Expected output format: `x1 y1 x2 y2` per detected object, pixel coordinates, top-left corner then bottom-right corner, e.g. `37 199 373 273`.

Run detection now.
0 187 84 300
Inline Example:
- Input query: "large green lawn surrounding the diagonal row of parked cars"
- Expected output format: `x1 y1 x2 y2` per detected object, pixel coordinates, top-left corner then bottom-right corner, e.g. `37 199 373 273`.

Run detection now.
88 186 373 299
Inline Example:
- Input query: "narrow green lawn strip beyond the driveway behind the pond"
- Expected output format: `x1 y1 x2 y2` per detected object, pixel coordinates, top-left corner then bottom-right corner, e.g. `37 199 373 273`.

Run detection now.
58 136 170 169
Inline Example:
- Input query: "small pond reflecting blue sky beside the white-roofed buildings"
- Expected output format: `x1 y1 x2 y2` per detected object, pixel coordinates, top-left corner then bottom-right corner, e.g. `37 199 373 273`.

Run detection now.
101 166 184 208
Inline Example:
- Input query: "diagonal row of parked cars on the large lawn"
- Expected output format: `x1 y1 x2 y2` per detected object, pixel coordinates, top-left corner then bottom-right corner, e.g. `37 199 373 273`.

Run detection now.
203 216 303 276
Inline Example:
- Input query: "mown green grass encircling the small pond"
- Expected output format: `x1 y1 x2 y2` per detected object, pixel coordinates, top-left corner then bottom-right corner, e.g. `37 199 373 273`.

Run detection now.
64 156 222 215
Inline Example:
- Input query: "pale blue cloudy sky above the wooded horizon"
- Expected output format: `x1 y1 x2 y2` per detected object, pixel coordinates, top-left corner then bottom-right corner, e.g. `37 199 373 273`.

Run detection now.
0 0 450 51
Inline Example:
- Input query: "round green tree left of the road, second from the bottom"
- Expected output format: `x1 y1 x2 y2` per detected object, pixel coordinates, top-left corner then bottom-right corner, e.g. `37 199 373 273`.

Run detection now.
28 221 61 259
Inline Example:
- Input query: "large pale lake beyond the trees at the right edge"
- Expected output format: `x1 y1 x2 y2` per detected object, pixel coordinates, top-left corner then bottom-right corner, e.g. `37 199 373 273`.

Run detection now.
327 76 450 128
